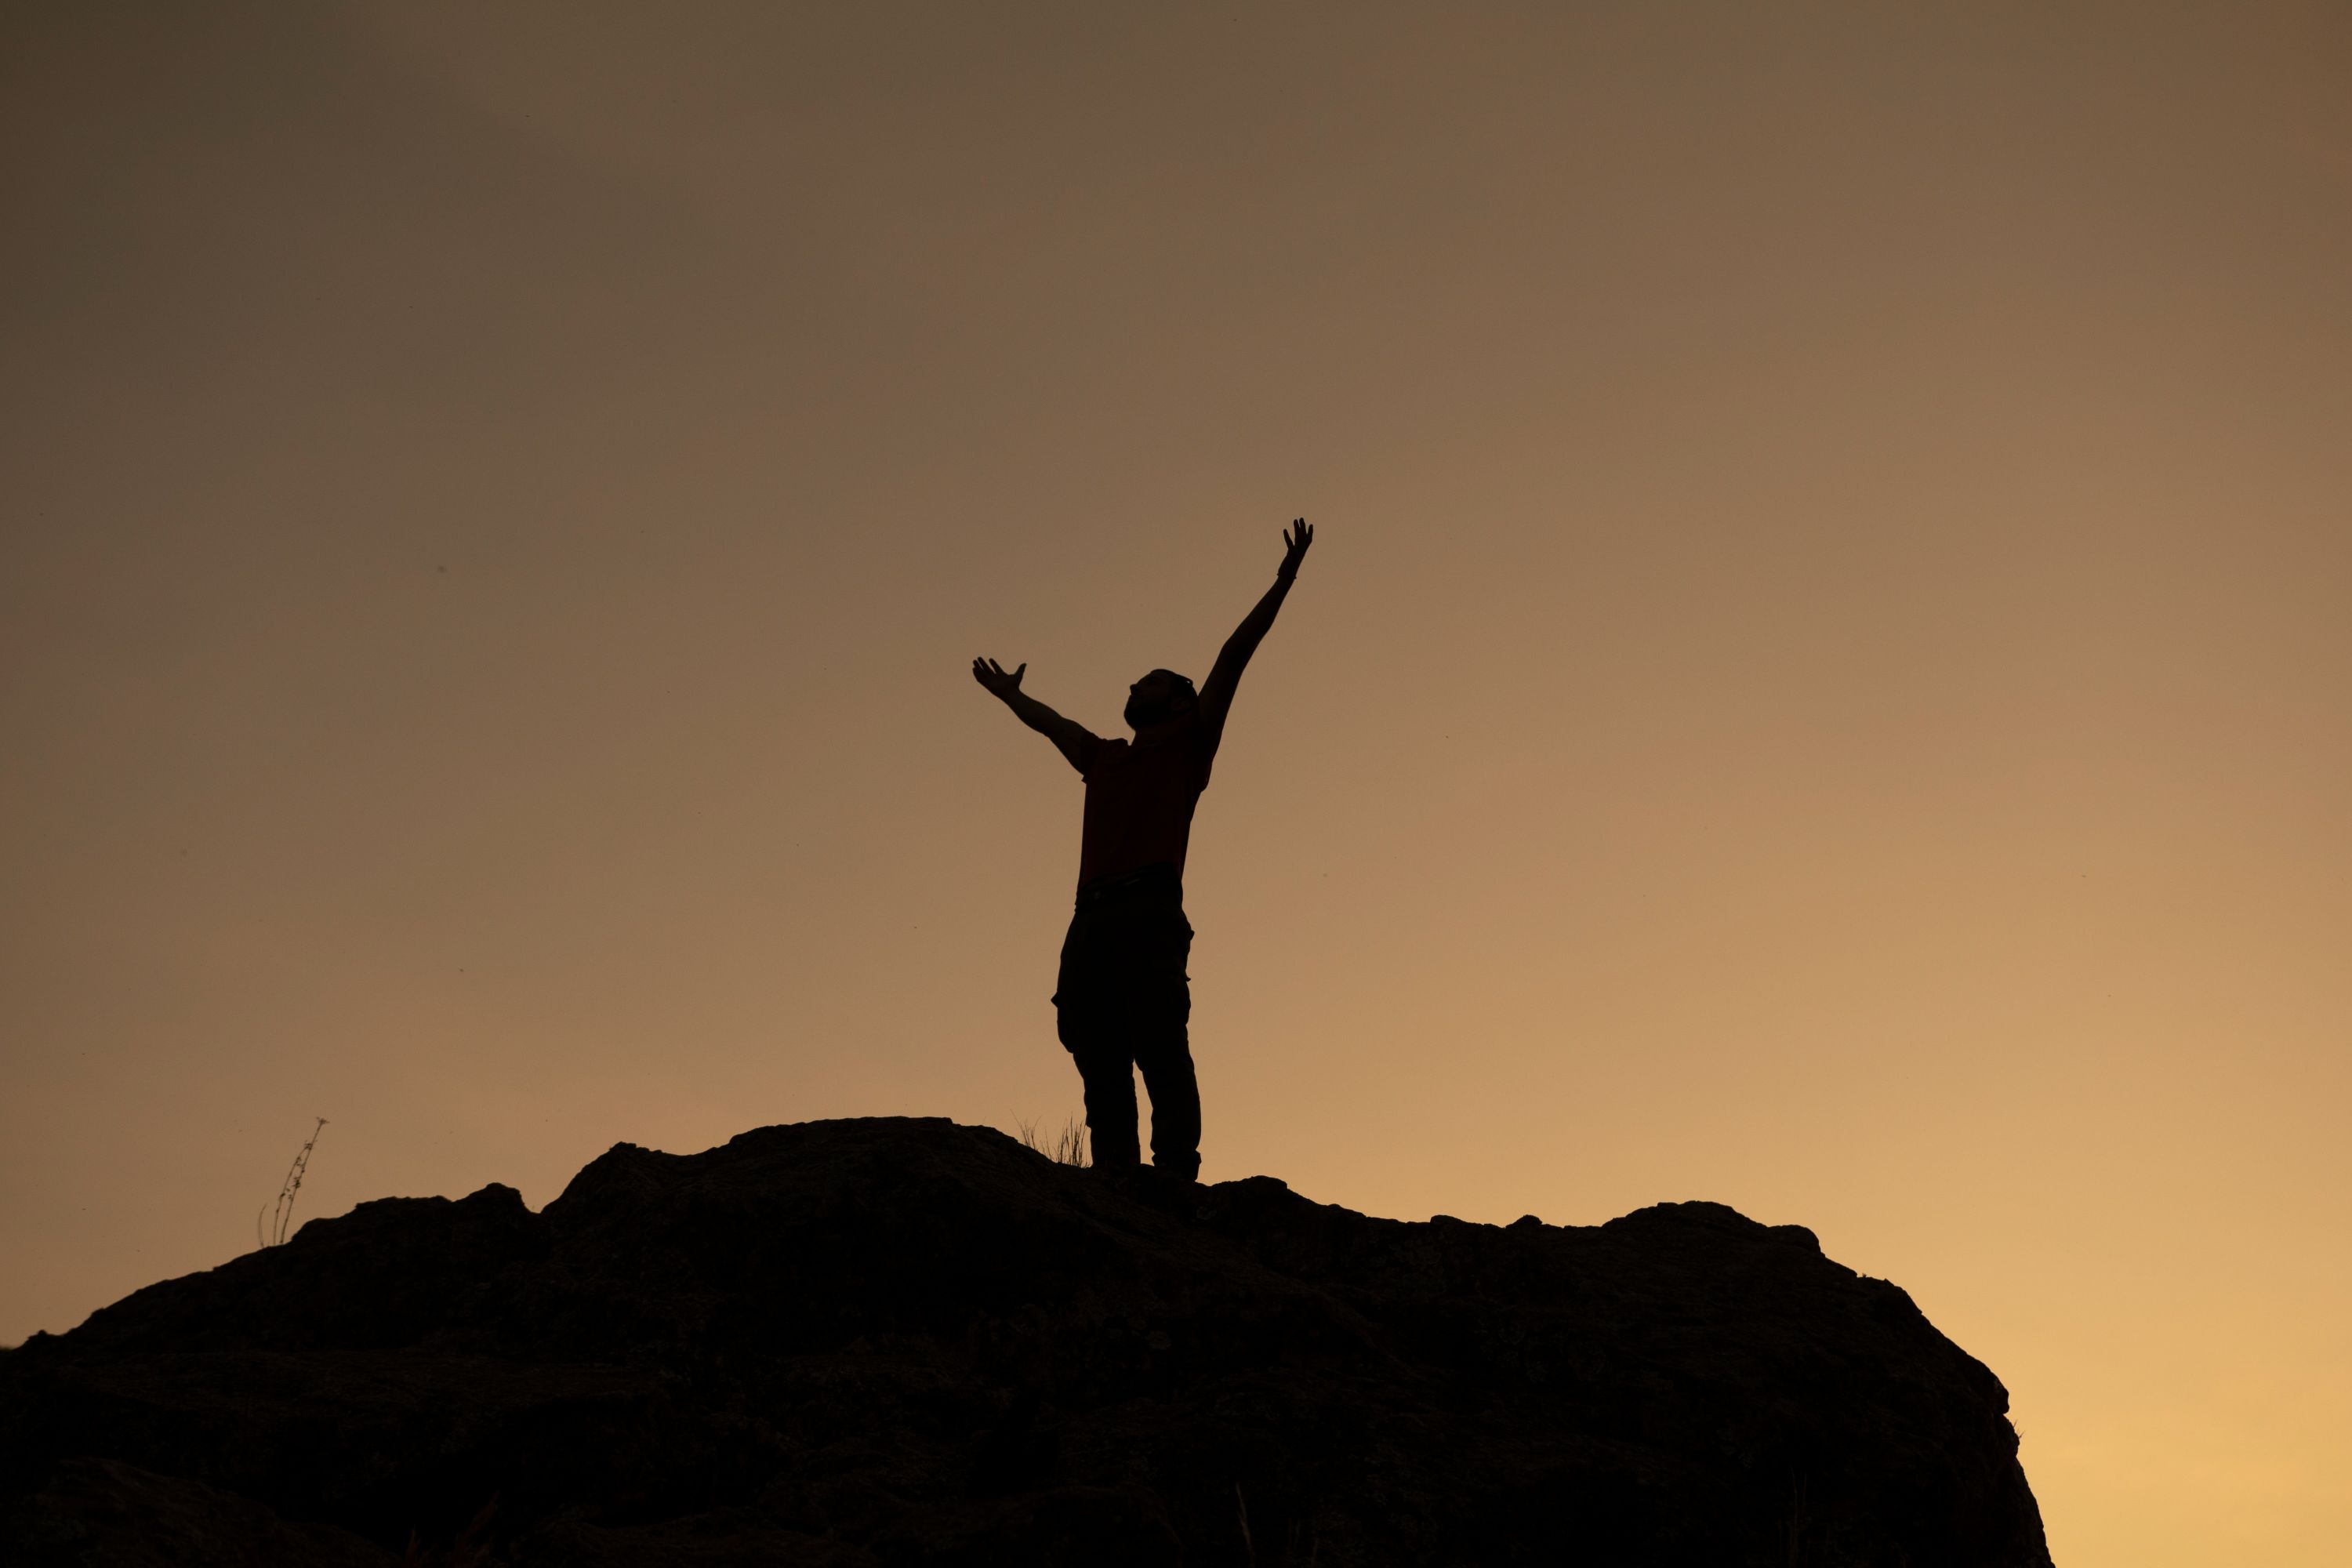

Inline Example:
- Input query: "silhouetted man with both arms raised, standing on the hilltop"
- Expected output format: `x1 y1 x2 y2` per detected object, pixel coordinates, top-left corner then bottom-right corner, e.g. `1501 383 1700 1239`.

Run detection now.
971 517 1315 1182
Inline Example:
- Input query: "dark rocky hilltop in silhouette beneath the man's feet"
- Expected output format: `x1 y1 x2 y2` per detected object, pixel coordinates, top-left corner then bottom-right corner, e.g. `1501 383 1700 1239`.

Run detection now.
0 1119 2049 1568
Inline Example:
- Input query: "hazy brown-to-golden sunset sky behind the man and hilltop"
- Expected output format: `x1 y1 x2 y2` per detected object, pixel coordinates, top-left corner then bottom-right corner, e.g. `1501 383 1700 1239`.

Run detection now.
0 0 2352 1568
